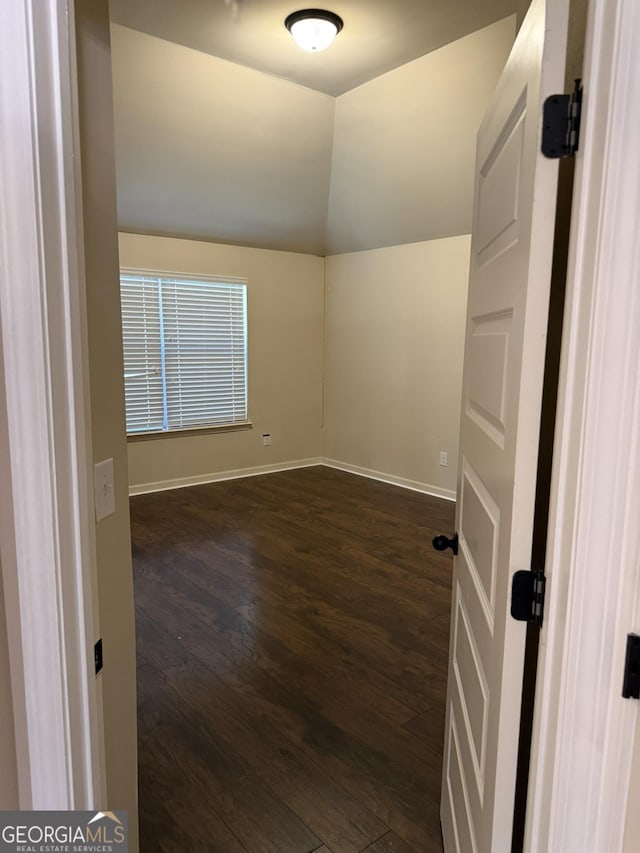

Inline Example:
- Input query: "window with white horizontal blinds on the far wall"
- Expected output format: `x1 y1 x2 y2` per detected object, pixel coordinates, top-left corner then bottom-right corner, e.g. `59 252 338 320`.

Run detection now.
120 270 247 434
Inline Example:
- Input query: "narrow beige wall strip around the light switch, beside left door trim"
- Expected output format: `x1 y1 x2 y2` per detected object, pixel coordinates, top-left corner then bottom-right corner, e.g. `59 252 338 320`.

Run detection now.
75 0 137 853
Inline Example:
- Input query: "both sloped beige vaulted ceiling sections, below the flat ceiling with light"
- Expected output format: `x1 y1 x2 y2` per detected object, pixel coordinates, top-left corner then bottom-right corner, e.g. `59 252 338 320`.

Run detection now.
112 16 515 255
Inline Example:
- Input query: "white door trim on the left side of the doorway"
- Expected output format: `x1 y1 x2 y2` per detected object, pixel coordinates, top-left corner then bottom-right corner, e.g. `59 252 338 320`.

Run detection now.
0 0 104 809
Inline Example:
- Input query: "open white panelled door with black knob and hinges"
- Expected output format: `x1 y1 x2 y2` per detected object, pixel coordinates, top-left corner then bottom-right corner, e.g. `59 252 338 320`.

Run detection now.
441 0 568 853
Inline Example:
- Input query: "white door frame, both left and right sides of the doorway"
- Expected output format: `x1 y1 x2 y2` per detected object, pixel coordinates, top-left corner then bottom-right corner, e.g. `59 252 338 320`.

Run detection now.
0 0 640 840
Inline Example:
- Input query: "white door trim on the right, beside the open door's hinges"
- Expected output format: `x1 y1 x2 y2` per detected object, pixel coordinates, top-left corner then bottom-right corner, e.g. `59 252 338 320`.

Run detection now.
526 0 640 853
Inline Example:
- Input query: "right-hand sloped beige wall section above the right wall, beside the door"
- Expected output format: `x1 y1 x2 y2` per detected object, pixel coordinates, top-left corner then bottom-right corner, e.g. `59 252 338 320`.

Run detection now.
327 15 516 254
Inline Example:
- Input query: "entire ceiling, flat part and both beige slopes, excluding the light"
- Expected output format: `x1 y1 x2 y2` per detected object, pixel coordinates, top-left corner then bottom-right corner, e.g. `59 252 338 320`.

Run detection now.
110 0 527 255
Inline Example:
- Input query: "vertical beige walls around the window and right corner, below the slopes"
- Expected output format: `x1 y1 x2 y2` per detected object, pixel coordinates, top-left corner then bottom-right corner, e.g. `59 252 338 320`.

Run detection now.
120 234 469 494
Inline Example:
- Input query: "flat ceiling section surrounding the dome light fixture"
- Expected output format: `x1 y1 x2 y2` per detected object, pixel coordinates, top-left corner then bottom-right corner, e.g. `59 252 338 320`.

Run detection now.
110 0 524 96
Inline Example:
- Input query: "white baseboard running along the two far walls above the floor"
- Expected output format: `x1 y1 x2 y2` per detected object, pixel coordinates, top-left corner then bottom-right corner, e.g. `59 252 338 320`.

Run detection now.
129 456 456 501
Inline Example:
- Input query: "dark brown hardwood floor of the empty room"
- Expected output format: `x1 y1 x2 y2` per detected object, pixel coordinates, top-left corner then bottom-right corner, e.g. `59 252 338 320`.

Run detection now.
131 467 453 853
